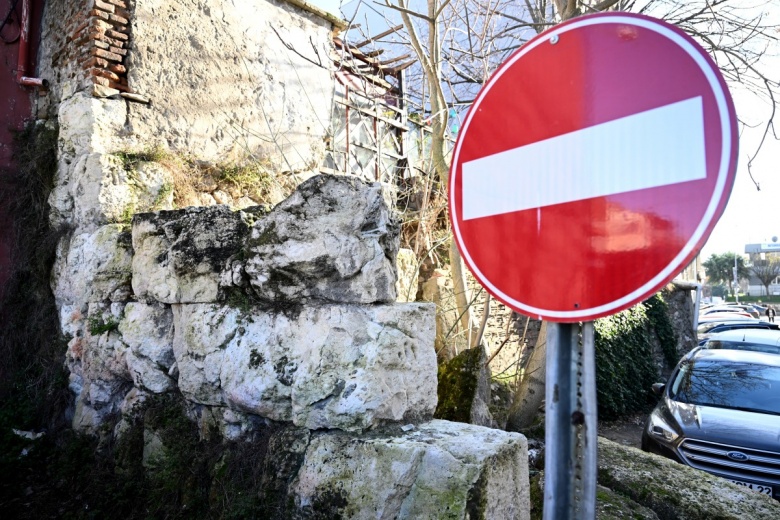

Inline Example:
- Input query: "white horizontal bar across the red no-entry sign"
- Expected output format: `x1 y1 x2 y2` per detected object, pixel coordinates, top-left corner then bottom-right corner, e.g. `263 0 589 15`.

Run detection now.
462 97 707 220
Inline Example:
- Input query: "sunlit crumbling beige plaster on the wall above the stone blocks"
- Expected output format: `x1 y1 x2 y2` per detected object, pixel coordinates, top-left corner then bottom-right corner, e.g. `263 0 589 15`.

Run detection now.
127 0 334 171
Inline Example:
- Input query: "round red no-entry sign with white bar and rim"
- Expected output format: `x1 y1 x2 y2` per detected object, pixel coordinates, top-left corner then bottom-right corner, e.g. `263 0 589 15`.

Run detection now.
449 13 738 322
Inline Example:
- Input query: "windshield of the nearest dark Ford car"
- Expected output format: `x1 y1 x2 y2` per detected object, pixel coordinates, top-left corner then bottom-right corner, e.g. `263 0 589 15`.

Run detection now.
669 360 780 415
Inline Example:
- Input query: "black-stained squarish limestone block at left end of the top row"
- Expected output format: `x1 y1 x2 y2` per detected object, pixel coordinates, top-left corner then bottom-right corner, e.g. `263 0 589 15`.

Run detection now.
133 206 260 303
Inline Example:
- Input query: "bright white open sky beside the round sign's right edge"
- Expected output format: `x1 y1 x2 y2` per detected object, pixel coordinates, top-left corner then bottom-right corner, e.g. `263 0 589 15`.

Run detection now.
308 0 780 260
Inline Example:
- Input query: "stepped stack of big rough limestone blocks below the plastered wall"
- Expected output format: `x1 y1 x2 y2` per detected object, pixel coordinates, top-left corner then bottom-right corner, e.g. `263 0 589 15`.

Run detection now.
53 167 529 518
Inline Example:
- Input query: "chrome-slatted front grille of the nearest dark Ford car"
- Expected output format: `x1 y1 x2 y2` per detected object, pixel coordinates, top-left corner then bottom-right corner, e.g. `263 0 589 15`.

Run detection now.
680 439 780 484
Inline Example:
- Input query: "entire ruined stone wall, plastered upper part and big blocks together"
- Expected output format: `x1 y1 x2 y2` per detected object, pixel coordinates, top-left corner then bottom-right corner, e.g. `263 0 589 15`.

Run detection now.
32 0 529 518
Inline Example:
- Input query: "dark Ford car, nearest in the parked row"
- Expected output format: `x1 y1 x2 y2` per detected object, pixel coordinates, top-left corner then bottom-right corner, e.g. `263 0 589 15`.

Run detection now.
642 348 780 500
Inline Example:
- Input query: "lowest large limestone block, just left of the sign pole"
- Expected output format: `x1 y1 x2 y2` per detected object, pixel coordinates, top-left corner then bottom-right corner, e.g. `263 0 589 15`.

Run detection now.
290 420 530 520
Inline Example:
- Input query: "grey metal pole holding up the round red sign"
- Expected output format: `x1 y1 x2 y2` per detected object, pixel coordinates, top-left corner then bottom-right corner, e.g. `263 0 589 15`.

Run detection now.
544 321 597 520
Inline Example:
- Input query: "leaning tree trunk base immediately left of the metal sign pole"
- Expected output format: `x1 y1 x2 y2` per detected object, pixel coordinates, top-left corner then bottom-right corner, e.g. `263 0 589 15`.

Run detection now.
506 321 547 432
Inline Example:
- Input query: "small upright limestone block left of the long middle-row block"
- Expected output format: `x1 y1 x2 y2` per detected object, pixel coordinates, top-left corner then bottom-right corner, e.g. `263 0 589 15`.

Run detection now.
118 303 176 393
